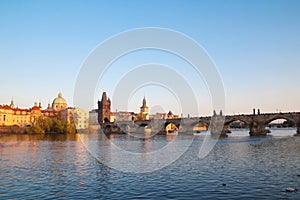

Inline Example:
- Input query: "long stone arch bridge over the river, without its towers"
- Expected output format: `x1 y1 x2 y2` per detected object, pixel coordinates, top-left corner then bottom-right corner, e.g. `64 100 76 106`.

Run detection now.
102 112 300 136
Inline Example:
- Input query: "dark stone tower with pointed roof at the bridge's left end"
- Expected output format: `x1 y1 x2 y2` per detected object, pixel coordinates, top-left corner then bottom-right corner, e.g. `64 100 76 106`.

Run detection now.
98 92 111 125
